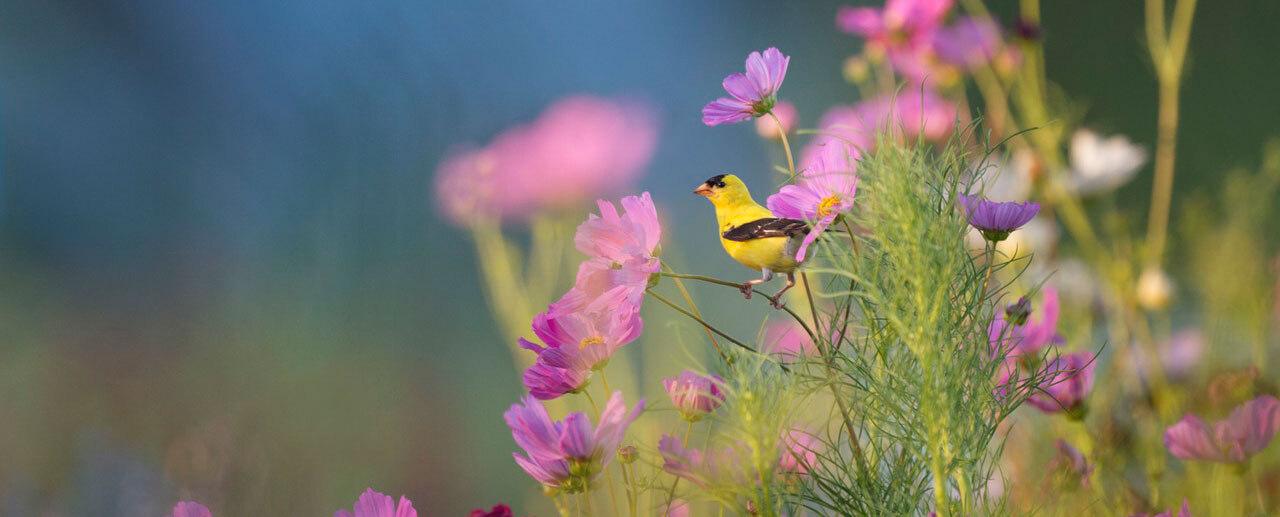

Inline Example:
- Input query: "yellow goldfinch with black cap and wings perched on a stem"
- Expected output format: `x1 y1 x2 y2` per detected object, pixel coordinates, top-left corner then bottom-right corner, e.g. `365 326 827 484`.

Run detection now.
694 174 809 308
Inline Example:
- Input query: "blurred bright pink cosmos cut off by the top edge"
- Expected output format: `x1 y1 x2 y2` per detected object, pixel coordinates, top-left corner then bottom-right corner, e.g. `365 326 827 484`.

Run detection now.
836 0 952 52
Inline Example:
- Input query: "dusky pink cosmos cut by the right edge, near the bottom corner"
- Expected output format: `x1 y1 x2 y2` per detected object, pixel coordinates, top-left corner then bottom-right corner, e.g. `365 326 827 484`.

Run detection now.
1165 395 1280 463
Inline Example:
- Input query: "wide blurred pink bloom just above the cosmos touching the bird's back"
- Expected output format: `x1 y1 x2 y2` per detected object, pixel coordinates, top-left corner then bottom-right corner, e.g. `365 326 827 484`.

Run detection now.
800 87 957 166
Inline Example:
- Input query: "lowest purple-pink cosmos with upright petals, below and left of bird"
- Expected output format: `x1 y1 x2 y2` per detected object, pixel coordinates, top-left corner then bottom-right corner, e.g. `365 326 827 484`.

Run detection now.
503 392 644 494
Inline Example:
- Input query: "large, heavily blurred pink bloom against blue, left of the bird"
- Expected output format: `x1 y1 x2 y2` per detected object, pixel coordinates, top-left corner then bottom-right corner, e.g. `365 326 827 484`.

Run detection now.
435 96 657 225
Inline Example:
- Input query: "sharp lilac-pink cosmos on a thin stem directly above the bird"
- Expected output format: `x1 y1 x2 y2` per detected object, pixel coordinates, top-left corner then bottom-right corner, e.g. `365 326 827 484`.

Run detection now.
703 47 791 125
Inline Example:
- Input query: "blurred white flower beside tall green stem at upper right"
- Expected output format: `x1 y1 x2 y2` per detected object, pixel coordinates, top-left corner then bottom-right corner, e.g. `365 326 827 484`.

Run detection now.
1070 129 1147 196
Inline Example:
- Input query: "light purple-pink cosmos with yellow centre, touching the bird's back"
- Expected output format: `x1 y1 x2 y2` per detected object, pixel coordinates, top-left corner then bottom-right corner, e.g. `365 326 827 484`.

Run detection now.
765 146 858 262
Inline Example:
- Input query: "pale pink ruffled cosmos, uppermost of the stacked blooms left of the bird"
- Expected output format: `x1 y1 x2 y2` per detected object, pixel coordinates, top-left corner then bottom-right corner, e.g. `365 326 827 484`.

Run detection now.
549 192 662 316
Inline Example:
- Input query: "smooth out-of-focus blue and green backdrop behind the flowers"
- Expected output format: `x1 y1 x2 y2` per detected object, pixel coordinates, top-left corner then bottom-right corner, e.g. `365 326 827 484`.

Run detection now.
0 0 1280 516
